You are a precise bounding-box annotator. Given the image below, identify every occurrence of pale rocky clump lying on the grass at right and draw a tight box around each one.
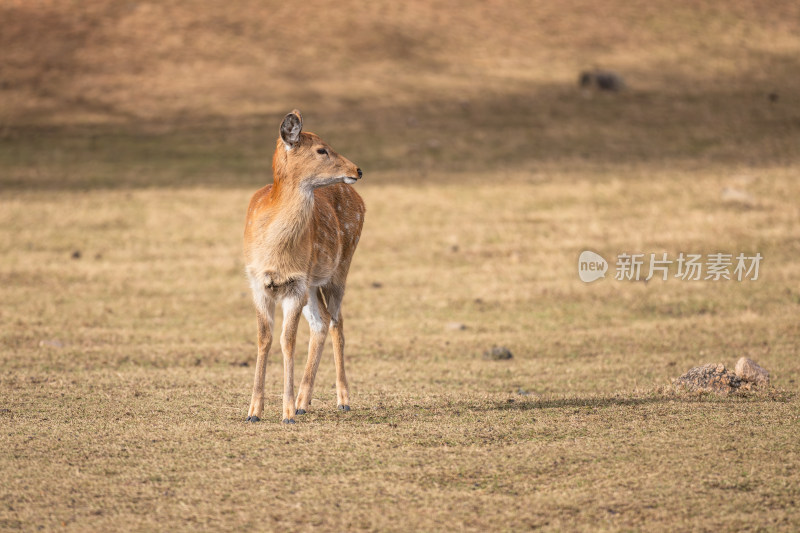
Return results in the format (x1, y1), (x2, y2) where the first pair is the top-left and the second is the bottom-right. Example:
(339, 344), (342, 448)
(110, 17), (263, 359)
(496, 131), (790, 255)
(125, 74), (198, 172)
(673, 357), (769, 395)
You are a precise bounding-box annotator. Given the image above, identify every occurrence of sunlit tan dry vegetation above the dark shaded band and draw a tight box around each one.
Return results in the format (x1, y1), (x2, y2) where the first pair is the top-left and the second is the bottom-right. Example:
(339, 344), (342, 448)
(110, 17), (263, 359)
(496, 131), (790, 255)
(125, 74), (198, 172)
(1, 0), (800, 124)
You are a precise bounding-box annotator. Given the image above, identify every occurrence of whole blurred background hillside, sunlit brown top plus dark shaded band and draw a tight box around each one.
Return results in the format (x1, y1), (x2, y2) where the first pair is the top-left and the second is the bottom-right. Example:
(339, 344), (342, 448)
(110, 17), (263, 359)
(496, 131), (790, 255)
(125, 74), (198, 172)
(0, 0), (800, 187)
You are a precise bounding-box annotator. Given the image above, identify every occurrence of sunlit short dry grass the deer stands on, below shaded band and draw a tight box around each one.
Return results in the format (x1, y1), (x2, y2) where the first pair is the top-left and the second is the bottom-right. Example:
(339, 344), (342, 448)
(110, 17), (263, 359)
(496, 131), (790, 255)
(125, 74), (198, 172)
(0, 172), (800, 530)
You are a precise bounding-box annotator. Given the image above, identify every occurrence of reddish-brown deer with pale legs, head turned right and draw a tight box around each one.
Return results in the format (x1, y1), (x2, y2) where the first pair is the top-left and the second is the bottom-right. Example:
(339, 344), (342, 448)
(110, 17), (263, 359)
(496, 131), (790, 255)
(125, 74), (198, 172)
(244, 109), (365, 424)
